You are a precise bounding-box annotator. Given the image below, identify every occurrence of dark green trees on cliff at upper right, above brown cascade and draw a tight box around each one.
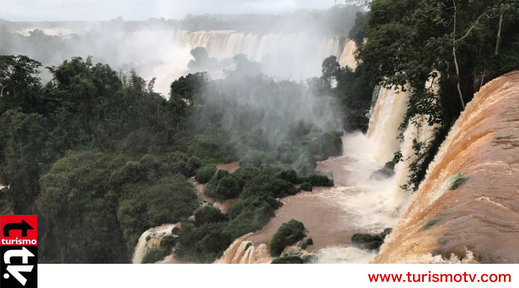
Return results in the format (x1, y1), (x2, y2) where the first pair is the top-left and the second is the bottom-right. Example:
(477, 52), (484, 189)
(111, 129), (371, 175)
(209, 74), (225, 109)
(356, 0), (519, 190)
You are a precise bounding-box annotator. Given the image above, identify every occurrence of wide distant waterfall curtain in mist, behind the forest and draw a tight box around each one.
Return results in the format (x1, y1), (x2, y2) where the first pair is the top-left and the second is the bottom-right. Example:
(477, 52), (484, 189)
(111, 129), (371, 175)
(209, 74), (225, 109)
(174, 31), (350, 80)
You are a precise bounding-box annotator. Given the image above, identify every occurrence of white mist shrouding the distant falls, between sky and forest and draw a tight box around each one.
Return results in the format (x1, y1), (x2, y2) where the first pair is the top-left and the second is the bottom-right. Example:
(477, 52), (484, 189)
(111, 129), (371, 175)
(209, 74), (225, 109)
(0, 5), (360, 98)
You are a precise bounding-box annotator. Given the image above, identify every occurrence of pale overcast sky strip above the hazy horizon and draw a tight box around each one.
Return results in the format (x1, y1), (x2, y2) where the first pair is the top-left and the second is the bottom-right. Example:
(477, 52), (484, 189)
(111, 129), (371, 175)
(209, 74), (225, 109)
(0, 0), (344, 21)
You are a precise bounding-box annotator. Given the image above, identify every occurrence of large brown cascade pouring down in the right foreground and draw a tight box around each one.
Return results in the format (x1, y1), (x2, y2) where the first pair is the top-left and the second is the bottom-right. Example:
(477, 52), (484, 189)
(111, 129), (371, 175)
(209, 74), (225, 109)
(375, 72), (519, 263)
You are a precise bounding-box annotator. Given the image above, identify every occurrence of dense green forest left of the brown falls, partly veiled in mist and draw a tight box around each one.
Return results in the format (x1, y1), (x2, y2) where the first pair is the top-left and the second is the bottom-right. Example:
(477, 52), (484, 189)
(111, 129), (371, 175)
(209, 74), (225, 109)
(0, 56), (348, 263)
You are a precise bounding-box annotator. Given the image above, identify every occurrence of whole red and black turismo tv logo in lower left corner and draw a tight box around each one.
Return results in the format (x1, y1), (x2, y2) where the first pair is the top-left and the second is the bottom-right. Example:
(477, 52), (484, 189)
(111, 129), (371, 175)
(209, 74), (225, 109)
(0, 215), (38, 288)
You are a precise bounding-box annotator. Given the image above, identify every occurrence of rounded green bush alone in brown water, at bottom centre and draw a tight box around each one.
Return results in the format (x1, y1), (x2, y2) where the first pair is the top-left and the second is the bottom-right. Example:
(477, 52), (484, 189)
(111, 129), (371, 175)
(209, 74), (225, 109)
(270, 220), (306, 256)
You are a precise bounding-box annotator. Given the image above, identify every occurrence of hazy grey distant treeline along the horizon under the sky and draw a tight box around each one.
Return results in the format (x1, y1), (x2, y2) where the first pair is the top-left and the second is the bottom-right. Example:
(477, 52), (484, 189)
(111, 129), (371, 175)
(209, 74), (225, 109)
(0, 5), (363, 36)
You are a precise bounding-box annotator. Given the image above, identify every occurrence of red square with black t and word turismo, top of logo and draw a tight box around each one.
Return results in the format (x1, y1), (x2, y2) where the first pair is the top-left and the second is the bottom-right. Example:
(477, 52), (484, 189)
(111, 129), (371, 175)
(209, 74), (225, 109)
(0, 215), (38, 246)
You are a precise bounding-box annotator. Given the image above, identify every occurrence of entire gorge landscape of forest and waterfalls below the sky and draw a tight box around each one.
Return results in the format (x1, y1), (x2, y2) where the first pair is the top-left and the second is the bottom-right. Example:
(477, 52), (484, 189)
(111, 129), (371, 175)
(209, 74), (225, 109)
(0, 0), (519, 264)
